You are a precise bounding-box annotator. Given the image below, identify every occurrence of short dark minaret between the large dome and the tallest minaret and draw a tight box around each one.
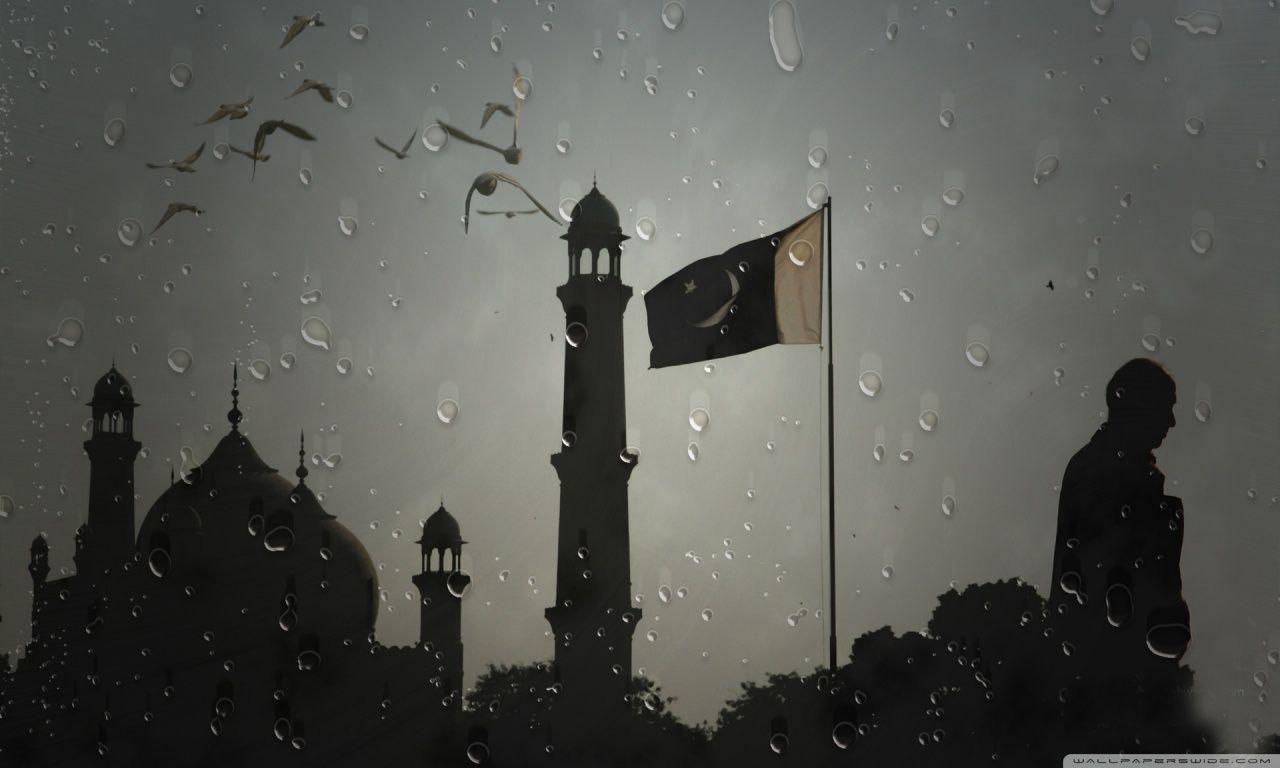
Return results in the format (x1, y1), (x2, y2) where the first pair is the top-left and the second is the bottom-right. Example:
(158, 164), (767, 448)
(413, 499), (471, 707)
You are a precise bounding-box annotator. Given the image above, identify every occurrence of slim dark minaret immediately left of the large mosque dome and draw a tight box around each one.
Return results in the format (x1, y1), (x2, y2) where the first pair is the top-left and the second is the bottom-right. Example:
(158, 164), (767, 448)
(77, 364), (142, 570)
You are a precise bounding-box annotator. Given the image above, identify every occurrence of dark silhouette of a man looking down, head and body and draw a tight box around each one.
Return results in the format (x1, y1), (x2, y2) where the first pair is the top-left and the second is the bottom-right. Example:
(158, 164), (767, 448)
(1050, 358), (1190, 671)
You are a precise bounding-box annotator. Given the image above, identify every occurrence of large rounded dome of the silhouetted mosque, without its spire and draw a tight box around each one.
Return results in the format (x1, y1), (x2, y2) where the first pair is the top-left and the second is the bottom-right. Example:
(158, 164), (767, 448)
(137, 430), (378, 641)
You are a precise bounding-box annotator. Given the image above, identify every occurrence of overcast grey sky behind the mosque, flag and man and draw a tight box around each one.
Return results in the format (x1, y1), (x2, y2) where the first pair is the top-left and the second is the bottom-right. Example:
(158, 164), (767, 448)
(0, 0), (1280, 745)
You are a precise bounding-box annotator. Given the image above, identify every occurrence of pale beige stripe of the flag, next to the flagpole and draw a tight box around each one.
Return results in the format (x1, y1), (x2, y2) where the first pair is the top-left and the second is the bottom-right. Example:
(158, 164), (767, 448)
(773, 210), (826, 344)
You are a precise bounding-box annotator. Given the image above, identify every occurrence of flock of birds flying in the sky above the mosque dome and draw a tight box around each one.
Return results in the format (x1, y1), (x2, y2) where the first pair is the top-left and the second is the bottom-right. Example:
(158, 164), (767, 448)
(146, 12), (559, 234)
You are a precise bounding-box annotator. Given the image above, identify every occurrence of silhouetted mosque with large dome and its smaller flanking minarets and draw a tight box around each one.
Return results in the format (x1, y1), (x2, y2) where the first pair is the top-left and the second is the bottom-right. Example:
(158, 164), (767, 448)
(0, 366), (466, 765)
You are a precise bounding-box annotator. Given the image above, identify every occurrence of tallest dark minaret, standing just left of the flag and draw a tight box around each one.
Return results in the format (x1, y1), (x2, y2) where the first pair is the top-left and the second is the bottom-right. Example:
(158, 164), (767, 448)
(547, 183), (640, 712)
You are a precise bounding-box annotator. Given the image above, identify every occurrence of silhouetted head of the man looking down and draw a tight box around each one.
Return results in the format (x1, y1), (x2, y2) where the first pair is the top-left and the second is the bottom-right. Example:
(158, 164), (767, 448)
(1107, 357), (1178, 451)
